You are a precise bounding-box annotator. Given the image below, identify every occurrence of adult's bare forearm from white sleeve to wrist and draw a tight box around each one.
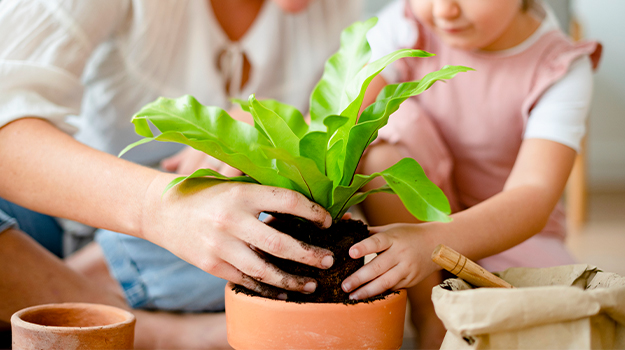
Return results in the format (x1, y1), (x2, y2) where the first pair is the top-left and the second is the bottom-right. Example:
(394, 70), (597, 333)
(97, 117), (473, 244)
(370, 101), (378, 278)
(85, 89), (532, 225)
(0, 118), (168, 236)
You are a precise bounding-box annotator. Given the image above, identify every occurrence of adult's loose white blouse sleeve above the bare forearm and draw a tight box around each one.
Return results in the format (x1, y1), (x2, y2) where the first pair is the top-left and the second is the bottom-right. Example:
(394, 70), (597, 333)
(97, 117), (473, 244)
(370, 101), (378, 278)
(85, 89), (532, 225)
(0, 0), (125, 132)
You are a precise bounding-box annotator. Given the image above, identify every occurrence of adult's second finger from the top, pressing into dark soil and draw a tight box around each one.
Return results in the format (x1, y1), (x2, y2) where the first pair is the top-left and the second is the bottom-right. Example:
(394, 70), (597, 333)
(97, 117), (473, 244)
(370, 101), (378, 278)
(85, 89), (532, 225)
(241, 216), (334, 270)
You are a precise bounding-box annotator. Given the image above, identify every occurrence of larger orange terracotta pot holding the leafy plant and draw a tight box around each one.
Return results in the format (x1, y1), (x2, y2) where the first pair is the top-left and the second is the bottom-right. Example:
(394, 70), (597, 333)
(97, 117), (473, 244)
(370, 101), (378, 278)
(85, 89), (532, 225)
(226, 283), (406, 350)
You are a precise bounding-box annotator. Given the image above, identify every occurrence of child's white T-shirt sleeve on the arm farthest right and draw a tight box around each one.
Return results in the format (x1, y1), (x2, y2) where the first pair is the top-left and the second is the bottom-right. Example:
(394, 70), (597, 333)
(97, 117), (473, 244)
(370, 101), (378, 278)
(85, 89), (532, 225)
(523, 56), (593, 152)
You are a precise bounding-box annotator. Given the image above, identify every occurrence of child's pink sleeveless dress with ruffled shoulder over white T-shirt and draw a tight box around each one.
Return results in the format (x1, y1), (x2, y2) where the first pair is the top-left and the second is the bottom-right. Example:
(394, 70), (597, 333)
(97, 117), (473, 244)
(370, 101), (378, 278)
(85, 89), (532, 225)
(380, 1), (600, 271)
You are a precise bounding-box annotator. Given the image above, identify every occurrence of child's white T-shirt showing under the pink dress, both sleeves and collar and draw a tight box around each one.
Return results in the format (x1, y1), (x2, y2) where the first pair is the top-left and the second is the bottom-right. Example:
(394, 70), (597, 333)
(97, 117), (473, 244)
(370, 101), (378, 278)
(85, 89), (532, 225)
(367, 0), (593, 151)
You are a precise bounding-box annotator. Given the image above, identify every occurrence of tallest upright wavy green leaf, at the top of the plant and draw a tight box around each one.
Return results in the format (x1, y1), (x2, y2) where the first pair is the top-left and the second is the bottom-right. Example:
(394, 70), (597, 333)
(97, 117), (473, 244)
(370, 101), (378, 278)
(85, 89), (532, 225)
(310, 17), (378, 131)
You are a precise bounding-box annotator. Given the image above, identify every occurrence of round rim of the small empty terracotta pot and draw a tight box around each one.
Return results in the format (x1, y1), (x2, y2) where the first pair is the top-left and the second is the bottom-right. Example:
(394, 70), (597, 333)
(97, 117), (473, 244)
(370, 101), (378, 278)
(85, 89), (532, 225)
(11, 303), (136, 333)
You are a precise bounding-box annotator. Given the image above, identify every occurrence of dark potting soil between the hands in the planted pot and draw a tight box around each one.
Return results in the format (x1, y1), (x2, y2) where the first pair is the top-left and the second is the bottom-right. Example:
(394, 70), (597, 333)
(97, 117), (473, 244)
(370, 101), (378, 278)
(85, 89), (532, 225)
(235, 214), (389, 303)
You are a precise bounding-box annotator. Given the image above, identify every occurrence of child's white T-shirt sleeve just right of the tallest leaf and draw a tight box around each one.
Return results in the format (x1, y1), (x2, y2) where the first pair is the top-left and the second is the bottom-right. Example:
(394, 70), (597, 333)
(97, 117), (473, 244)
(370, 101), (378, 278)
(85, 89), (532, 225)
(367, 0), (418, 84)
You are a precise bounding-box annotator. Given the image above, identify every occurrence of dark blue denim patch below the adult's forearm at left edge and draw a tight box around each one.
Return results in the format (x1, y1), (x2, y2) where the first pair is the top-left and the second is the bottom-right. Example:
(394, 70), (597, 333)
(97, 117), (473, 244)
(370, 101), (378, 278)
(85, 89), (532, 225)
(0, 198), (63, 258)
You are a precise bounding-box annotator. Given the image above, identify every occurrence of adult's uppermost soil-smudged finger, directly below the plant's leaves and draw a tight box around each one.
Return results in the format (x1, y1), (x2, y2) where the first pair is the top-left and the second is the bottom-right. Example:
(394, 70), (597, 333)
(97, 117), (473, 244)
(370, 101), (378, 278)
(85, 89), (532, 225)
(248, 186), (332, 228)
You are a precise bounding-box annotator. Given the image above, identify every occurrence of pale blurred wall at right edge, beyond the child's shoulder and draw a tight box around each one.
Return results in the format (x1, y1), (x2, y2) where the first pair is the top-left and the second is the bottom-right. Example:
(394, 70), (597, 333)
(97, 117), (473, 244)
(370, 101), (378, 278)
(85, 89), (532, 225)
(572, 0), (625, 192)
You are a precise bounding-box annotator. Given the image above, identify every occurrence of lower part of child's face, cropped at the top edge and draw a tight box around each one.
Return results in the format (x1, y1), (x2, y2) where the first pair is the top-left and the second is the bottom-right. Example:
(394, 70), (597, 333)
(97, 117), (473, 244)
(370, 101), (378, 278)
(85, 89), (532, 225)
(411, 0), (523, 50)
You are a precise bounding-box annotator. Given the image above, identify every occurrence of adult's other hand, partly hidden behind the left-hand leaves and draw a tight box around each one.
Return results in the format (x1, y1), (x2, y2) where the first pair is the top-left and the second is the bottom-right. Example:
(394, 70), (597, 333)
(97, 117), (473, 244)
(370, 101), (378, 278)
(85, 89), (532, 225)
(161, 147), (242, 177)
